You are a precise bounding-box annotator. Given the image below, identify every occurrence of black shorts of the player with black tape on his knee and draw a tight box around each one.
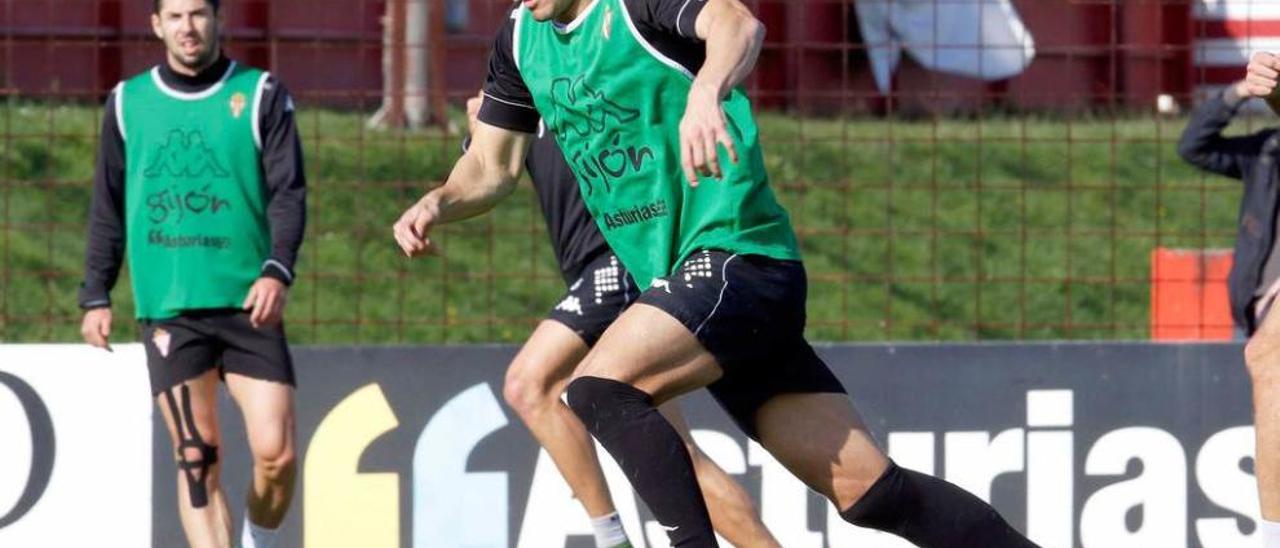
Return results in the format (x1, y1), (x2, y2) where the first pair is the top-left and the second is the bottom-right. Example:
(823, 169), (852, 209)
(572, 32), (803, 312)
(142, 309), (296, 396)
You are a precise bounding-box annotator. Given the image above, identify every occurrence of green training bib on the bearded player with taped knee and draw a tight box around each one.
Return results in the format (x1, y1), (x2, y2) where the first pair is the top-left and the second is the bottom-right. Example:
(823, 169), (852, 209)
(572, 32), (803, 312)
(115, 63), (271, 319)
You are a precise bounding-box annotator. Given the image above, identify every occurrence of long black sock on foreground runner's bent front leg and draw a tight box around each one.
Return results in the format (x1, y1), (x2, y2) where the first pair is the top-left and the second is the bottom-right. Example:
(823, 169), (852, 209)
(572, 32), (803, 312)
(567, 376), (717, 548)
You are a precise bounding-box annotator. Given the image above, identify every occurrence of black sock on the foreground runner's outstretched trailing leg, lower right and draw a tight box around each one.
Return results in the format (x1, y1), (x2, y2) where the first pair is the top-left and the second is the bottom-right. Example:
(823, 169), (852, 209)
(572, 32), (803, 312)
(840, 462), (1036, 548)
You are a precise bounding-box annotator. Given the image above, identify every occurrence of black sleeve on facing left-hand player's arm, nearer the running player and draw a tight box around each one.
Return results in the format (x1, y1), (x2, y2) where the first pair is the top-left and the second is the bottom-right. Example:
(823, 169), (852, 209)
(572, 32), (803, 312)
(259, 77), (307, 284)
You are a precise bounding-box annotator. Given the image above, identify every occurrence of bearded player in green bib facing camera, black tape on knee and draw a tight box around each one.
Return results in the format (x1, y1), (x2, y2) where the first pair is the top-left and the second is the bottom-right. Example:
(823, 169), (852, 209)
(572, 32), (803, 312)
(79, 0), (306, 548)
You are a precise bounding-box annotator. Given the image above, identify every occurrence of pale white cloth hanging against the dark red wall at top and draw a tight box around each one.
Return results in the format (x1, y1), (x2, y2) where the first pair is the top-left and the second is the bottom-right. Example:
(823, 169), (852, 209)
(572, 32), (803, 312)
(855, 0), (1036, 92)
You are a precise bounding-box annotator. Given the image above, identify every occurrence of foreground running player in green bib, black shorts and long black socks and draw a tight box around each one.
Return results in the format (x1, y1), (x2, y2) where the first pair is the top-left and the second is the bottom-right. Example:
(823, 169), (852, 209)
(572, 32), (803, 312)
(394, 0), (1034, 548)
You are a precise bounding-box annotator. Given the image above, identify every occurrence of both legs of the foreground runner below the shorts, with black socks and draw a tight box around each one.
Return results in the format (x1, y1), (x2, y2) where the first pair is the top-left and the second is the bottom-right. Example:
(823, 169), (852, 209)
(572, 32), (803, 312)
(568, 303), (1034, 548)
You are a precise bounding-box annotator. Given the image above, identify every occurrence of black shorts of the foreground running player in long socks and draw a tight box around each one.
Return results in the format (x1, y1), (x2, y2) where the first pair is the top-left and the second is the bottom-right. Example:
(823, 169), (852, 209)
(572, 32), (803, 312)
(639, 251), (846, 439)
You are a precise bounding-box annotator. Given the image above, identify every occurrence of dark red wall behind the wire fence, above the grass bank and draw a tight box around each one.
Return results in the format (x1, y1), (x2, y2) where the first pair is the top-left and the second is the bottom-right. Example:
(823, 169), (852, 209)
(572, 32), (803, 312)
(0, 0), (1194, 111)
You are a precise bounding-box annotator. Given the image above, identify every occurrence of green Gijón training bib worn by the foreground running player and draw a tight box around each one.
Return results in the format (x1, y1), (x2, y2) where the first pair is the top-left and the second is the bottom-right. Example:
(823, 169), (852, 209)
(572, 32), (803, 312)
(512, 0), (800, 288)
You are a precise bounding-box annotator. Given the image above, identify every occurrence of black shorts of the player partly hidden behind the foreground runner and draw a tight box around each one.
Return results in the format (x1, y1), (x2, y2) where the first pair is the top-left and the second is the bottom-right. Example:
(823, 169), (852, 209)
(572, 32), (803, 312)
(547, 254), (640, 346)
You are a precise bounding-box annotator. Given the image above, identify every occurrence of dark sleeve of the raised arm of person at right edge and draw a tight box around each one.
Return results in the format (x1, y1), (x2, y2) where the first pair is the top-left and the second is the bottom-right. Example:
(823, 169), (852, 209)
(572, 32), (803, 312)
(1178, 89), (1271, 179)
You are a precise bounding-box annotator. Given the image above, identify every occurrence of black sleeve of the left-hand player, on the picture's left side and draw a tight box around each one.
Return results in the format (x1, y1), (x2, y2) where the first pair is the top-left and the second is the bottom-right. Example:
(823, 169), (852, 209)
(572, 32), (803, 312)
(78, 91), (124, 310)
